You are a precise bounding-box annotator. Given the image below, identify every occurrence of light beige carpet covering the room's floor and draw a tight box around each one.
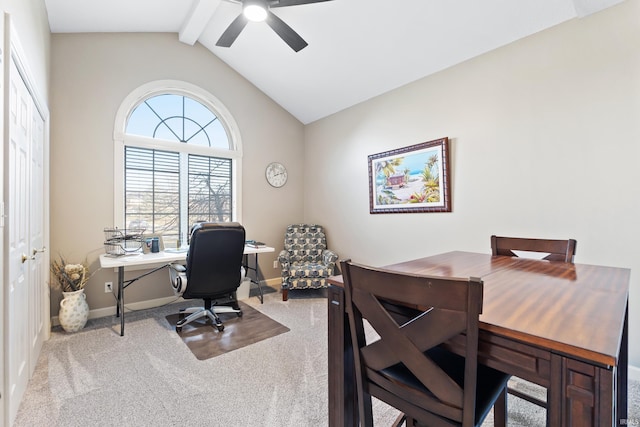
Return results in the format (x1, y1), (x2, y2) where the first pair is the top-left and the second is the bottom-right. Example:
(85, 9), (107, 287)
(13, 287), (640, 427)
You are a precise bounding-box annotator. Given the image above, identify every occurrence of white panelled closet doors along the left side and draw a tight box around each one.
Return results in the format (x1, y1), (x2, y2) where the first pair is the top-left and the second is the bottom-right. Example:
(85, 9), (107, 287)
(4, 56), (48, 423)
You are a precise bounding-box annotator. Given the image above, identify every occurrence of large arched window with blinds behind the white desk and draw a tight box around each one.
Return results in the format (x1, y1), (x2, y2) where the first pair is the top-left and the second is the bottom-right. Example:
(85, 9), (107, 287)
(114, 81), (242, 247)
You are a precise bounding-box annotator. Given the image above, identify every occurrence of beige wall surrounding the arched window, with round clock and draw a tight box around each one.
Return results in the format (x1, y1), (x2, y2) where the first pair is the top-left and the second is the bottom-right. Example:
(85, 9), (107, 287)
(51, 34), (304, 316)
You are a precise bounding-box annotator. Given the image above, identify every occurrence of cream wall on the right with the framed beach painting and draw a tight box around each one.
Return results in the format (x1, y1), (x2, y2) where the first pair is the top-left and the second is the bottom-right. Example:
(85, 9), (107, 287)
(304, 0), (640, 367)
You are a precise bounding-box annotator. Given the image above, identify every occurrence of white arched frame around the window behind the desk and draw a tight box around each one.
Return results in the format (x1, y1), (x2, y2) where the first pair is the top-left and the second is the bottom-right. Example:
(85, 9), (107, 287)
(113, 80), (242, 234)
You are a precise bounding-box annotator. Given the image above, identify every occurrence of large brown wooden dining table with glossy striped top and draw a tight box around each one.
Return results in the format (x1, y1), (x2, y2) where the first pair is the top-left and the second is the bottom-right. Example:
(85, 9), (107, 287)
(328, 251), (630, 427)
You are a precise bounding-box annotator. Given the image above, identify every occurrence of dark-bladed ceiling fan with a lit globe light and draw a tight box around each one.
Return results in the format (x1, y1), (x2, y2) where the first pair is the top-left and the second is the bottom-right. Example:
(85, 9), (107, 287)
(216, 0), (331, 52)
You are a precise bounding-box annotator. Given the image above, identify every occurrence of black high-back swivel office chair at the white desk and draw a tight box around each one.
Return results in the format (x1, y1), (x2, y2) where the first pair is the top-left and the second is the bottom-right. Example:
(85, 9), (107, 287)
(169, 222), (245, 332)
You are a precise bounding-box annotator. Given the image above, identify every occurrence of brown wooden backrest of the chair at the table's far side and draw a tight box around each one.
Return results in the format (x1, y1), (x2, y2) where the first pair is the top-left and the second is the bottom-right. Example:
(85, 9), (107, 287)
(491, 236), (577, 263)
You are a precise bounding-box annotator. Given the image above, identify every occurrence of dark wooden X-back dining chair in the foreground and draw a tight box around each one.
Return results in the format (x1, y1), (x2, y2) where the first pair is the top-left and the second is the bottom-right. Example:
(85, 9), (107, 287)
(342, 261), (509, 427)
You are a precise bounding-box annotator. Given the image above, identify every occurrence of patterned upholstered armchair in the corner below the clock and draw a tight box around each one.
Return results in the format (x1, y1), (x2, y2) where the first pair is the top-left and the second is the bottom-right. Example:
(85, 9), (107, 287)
(278, 224), (338, 301)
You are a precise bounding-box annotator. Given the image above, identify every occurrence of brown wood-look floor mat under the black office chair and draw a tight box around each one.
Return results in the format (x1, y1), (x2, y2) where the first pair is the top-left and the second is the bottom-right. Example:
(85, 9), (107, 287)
(166, 301), (289, 360)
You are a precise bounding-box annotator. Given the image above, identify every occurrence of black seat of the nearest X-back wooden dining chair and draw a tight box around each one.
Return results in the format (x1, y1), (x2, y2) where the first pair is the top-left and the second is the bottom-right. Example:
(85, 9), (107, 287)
(381, 348), (510, 426)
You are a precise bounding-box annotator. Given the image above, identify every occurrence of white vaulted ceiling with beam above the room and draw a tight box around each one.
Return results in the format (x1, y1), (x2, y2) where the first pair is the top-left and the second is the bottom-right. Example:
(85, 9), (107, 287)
(45, 0), (623, 124)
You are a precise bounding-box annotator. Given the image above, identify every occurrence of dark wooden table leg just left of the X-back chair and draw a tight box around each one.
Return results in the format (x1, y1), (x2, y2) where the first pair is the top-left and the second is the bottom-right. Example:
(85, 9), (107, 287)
(327, 285), (358, 427)
